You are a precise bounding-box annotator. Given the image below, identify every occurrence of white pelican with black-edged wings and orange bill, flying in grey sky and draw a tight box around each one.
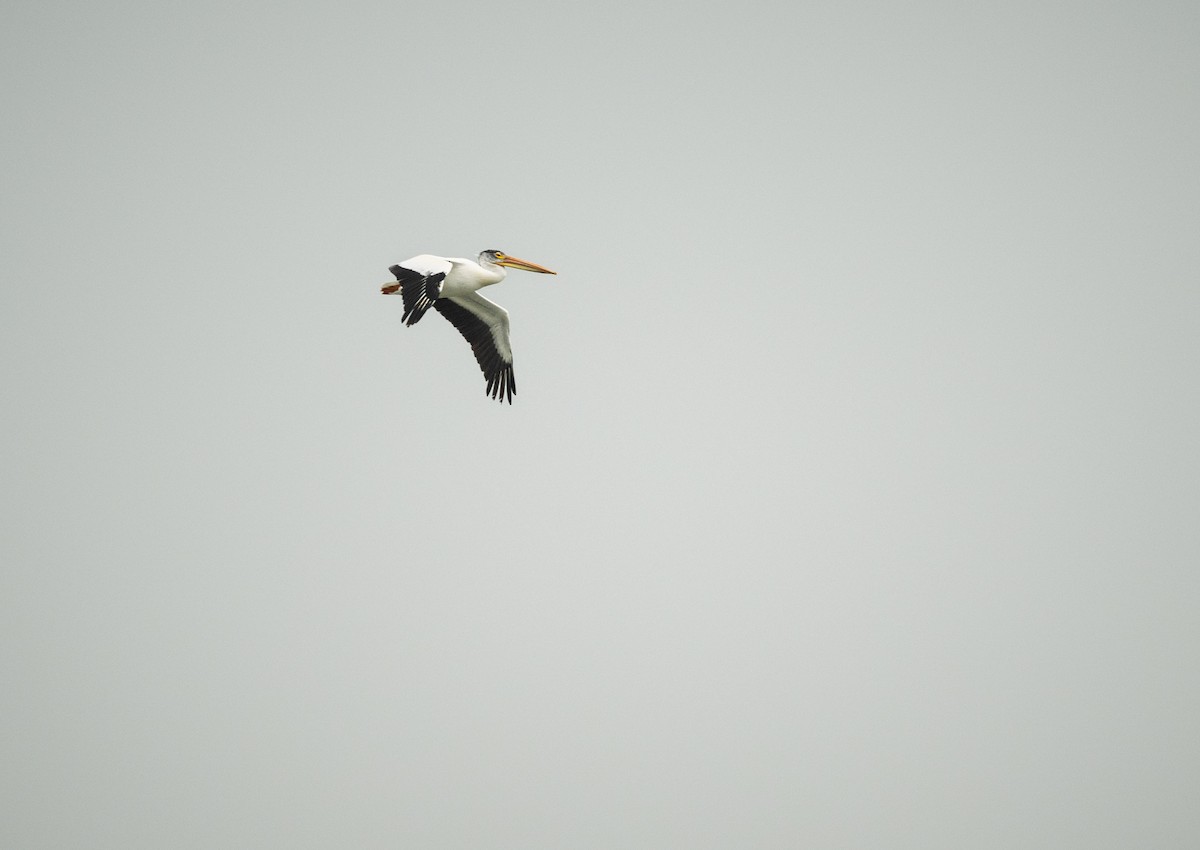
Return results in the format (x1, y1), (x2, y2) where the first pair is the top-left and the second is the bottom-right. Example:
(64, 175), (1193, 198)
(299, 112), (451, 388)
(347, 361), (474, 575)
(382, 251), (558, 405)
